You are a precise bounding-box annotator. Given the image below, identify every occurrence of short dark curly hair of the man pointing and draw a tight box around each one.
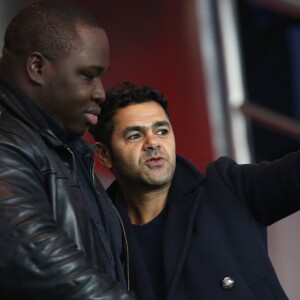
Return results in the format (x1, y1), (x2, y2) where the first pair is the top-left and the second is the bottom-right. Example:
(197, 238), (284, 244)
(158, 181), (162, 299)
(89, 82), (170, 147)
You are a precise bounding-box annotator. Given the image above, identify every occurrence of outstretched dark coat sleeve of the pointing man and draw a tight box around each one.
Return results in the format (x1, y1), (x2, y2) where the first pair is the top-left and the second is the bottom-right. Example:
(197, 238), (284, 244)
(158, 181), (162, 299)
(209, 152), (300, 225)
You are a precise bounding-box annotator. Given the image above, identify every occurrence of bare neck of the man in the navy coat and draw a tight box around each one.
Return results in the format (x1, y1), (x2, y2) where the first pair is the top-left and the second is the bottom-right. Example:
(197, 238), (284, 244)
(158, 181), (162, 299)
(122, 186), (170, 225)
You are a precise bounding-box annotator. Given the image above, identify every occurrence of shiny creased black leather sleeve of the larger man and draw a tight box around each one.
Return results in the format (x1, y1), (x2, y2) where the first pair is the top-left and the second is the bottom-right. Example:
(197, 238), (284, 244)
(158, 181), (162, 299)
(0, 134), (135, 300)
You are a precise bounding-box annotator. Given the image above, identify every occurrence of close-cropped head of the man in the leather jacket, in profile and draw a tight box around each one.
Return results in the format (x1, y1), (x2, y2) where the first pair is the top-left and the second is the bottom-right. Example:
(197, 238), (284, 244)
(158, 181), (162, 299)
(0, 0), (109, 135)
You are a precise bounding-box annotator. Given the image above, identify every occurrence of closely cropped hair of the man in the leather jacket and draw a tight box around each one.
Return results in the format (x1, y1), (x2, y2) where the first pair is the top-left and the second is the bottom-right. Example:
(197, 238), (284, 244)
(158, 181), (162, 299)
(4, 0), (102, 60)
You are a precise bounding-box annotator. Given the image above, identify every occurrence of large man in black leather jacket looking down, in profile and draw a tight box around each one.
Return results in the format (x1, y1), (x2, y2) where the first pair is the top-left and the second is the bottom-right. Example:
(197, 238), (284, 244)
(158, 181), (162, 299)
(0, 1), (134, 300)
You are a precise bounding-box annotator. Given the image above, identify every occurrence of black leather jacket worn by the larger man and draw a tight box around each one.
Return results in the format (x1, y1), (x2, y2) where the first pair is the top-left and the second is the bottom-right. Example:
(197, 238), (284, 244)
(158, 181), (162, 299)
(0, 85), (134, 300)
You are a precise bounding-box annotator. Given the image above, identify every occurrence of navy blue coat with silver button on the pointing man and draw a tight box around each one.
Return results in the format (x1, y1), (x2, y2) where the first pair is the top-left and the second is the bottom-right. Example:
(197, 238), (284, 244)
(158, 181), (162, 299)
(109, 153), (300, 300)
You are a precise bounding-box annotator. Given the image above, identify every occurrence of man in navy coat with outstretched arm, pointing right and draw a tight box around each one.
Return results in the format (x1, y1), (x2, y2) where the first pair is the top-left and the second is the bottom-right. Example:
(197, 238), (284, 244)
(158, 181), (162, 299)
(90, 83), (300, 300)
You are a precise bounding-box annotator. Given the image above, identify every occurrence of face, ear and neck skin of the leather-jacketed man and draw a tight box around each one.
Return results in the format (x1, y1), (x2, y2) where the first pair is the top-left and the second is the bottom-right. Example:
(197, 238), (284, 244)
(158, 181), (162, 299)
(0, 25), (109, 135)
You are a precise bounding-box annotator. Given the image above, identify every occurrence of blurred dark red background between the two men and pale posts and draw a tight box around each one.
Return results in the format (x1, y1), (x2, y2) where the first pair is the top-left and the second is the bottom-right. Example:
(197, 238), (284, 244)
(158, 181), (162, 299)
(72, 0), (213, 170)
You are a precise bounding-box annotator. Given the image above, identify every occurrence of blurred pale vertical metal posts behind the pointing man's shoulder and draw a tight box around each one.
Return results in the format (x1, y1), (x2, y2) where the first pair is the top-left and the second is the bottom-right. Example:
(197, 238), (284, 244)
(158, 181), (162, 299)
(197, 0), (251, 163)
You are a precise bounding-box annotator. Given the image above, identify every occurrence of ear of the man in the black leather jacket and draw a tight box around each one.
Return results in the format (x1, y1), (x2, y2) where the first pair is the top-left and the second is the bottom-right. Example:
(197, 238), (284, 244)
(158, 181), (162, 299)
(26, 52), (46, 84)
